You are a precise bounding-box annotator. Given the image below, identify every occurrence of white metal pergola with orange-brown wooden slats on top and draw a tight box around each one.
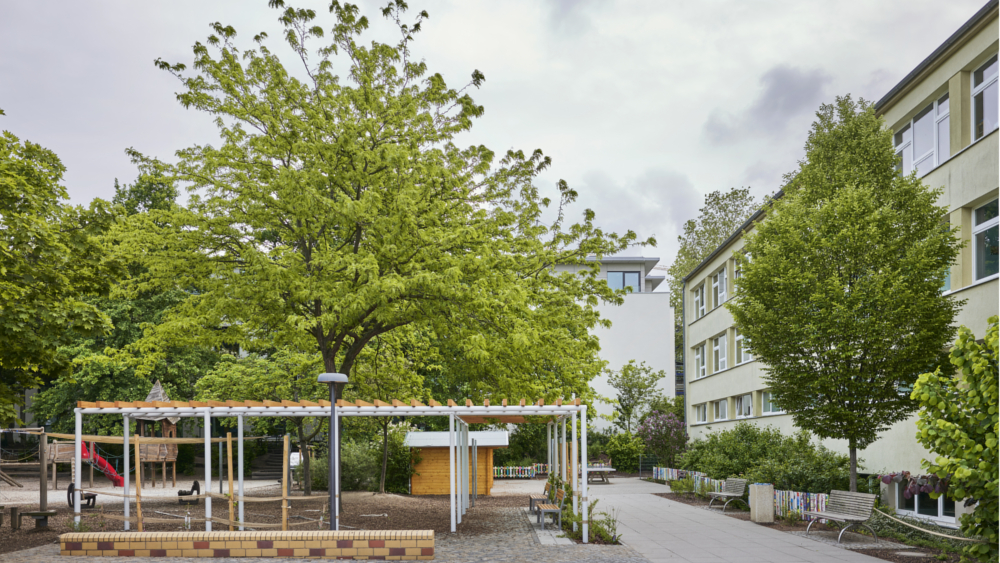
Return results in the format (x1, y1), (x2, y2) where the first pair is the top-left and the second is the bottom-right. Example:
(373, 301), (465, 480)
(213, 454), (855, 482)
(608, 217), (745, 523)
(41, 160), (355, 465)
(73, 399), (589, 543)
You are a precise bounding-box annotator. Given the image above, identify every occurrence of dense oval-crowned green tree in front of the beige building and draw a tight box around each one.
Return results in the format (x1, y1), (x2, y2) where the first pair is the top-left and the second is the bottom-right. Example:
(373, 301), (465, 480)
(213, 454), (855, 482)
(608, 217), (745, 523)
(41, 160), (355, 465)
(727, 96), (959, 491)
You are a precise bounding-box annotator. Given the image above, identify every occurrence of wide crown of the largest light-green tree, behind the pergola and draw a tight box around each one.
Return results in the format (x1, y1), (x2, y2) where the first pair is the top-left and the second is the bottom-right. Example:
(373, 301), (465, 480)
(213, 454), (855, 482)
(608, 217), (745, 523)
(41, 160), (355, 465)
(113, 1), (636, 404)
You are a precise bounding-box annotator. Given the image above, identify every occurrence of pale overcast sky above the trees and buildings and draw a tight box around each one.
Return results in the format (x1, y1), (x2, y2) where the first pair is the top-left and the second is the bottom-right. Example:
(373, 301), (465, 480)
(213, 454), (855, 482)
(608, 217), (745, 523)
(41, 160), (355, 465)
(0, 0), (985, 280)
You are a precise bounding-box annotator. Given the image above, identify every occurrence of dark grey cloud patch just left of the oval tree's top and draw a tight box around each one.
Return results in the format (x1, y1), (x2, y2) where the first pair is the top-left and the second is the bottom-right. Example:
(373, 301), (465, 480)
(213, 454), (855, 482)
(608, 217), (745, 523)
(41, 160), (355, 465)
(704, 64), (832, 144)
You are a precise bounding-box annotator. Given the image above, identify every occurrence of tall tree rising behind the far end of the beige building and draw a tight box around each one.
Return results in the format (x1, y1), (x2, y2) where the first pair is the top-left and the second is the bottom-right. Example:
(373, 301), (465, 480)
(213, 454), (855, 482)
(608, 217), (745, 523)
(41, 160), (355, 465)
(667, 188), (760, 358)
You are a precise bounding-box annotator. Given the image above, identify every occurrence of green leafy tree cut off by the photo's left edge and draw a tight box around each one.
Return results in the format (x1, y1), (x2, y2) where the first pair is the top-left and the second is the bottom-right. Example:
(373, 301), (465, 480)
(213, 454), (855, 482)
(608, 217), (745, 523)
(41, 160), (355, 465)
(0, 131), (119, 425)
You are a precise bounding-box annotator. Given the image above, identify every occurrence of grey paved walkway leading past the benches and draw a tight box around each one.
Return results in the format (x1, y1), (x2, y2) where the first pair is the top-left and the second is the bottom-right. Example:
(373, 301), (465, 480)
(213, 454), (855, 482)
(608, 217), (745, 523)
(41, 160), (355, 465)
(588, 478), (881, 563)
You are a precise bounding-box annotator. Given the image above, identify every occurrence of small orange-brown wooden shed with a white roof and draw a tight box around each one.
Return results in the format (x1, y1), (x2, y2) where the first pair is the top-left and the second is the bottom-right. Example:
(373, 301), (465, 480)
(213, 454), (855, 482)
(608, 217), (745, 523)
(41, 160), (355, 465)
(404, 430), (509, 495)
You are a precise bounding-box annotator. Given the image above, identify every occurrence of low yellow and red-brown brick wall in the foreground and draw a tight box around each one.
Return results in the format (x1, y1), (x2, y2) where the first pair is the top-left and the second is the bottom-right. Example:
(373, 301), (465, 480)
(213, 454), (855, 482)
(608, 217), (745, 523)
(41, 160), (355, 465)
(59, 530), (434, 560)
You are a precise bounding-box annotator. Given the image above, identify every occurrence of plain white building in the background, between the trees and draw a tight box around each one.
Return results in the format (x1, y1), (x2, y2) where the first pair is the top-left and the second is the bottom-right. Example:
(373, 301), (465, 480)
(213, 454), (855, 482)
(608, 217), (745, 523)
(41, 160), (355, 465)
(556, 256), (676, 429)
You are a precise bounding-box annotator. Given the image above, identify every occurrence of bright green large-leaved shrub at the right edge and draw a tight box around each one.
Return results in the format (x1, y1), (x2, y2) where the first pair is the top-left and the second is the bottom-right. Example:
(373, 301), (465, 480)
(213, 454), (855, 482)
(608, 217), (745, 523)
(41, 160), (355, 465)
(910, 316), (1000, 561)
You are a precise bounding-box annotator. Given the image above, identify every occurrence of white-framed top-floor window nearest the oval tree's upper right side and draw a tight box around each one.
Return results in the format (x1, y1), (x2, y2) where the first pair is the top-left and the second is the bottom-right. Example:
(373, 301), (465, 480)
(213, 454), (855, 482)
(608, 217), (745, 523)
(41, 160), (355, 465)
(894, 94), (951, 176)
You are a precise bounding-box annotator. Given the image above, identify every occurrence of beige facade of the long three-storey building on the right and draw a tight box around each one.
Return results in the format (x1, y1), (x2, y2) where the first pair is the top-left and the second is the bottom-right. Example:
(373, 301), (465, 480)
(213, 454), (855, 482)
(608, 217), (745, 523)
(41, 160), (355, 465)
(684, 2), (1000, 525)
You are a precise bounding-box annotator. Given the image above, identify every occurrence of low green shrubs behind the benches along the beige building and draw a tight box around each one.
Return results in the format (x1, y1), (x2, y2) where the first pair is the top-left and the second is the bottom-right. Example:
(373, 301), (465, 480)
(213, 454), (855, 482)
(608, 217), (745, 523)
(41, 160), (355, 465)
(680, 422), (850, 493)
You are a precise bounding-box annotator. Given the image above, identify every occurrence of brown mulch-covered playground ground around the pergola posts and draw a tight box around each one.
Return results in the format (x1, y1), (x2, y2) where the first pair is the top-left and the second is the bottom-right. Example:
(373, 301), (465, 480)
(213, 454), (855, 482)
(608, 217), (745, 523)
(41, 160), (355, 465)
(0, 485), (528, 554)
